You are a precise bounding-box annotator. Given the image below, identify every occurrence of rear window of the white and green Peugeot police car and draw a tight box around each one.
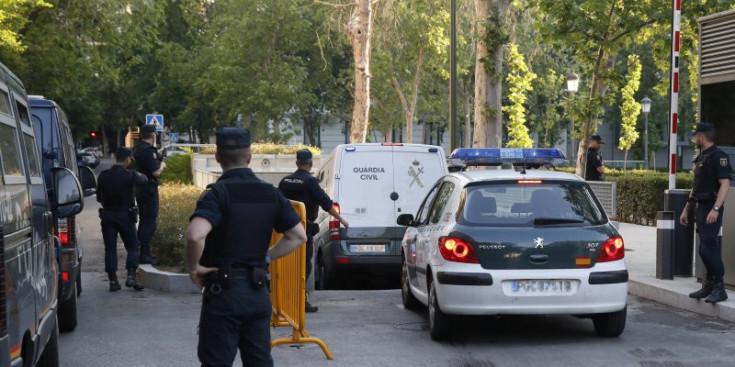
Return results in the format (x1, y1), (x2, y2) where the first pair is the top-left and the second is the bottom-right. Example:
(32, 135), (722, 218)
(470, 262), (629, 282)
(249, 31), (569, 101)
(460, 180), (607, 227)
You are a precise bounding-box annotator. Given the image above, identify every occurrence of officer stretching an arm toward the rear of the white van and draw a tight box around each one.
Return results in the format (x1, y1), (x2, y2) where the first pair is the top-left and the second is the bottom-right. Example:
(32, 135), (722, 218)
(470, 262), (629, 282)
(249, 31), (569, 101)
(278, 149), (349, 312)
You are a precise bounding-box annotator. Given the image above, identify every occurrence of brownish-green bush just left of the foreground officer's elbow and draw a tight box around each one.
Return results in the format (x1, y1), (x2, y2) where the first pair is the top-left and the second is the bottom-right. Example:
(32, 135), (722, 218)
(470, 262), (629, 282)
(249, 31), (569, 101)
(151, 183), (202, 272)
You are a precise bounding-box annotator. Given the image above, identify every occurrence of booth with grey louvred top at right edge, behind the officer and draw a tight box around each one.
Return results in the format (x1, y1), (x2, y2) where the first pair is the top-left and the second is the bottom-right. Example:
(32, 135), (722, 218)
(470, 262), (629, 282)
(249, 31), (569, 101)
(696, 10), (735, 287)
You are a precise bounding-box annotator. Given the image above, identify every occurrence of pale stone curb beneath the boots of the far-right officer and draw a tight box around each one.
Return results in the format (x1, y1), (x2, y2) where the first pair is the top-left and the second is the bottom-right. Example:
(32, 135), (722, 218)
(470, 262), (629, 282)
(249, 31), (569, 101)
(628, 279), (735, 323)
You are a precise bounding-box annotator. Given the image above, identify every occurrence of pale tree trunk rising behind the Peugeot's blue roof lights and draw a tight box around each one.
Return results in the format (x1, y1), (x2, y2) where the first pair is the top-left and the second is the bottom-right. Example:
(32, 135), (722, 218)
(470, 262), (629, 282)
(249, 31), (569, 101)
(472, 0), (490, 148)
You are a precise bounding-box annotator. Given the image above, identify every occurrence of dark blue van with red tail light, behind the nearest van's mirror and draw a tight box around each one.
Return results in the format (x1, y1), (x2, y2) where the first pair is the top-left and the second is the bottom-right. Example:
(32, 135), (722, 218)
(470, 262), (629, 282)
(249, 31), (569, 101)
(28, 96), (97, 332)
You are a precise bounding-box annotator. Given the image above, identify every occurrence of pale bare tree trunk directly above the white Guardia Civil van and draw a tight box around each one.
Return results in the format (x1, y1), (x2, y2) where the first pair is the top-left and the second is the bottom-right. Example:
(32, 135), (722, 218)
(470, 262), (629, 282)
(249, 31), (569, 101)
(345, 0), (374, 144)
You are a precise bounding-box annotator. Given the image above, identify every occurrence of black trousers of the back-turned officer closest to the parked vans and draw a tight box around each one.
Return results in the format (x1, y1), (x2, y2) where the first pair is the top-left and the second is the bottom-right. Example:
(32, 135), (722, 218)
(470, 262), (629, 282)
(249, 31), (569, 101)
(100, 210), (139, 273)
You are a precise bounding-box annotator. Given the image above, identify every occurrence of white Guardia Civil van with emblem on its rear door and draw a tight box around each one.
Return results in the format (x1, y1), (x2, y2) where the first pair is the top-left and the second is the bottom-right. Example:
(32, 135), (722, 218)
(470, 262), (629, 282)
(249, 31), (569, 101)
(314, 143), (447, 289)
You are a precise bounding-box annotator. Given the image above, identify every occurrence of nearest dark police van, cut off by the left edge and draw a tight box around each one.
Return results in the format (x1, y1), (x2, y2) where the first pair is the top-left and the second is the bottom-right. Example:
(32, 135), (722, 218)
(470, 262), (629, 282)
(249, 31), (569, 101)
(0, 59), (83, 367)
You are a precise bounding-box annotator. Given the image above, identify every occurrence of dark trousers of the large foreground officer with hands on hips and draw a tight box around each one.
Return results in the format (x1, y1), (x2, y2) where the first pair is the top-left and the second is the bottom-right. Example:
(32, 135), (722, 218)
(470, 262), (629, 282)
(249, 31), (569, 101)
(198, 276), (273, 367)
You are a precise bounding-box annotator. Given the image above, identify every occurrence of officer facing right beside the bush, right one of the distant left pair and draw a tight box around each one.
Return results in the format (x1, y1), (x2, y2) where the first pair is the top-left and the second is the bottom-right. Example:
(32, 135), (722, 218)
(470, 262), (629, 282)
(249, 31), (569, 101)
(133, 125), (166, 265)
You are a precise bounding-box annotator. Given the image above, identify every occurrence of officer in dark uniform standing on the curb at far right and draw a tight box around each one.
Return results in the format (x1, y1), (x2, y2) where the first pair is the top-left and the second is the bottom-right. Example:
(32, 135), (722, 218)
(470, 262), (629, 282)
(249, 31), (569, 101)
(679, 123), (732, 303)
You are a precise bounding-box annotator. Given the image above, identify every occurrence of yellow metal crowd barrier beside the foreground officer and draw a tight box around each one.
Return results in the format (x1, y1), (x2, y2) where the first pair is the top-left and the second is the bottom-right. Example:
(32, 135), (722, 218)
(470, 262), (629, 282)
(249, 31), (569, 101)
(269, 201), (332, 359)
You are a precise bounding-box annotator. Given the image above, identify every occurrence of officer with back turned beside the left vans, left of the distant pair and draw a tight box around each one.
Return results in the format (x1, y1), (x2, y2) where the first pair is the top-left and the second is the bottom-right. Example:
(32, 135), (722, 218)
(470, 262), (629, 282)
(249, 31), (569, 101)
(97, 147), (148, 292)
